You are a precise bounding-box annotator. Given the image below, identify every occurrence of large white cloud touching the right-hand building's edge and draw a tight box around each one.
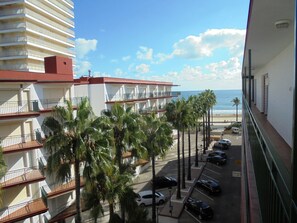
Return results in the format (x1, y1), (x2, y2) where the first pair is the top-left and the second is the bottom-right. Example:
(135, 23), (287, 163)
(172, 29), (245, 58)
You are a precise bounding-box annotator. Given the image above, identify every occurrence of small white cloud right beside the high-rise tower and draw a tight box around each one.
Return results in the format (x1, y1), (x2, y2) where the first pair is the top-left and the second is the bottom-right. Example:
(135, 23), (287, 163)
(74, 38), (97, 59)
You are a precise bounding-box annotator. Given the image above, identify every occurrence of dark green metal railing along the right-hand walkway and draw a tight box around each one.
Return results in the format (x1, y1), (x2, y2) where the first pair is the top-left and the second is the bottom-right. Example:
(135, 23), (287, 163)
(243, 100), (291, 222)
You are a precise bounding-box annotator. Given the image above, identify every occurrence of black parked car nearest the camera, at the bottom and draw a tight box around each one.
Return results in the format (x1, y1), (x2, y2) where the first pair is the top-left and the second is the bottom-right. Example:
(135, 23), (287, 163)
(185, 197), (213, 220)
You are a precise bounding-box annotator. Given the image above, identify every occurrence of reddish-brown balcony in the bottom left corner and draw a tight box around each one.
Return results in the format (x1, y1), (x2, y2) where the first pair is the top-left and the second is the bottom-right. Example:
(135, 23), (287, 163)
(0, 198), (48, 223)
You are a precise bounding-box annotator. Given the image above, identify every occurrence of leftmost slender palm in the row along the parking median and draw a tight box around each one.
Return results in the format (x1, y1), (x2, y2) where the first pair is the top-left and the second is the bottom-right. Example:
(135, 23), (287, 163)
(165, 99), (184, 199)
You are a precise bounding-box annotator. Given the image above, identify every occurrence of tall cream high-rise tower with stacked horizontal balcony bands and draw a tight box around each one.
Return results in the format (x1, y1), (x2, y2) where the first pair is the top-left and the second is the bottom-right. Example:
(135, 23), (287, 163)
(0, 0), (74, 73)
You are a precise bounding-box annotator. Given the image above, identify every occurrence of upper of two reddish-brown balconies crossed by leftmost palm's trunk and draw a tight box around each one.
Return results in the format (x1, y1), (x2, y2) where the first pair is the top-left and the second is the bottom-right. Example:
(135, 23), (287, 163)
(41, 177), (85, 203)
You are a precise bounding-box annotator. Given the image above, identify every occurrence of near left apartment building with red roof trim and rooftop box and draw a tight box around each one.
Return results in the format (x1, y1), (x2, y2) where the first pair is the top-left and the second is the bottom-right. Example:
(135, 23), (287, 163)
(0, 57), (83, 223)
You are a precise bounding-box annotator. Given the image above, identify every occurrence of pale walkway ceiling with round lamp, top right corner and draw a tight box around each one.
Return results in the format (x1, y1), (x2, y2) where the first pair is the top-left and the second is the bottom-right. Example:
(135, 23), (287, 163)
(243, 0), (295, 72)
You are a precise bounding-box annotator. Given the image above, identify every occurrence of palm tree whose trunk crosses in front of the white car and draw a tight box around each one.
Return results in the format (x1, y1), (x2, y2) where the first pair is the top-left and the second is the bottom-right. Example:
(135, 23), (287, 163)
(143, 113), (173, 223)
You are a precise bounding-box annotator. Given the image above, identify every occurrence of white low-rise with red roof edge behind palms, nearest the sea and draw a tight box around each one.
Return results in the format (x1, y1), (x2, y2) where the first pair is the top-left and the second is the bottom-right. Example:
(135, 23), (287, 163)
(74, 77), (179, 116)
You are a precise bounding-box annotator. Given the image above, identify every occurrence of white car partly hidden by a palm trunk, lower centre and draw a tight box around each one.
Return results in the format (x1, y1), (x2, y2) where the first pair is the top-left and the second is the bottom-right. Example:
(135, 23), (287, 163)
(136, 190), (165, 207)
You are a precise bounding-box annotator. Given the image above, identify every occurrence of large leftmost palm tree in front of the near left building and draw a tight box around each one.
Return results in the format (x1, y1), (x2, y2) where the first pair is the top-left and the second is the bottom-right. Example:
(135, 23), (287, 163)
(42, 98), (94, 223)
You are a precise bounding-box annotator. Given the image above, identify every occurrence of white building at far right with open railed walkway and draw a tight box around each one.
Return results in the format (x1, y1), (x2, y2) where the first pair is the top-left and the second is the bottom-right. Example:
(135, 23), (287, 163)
(241, 0), (297, 223)
